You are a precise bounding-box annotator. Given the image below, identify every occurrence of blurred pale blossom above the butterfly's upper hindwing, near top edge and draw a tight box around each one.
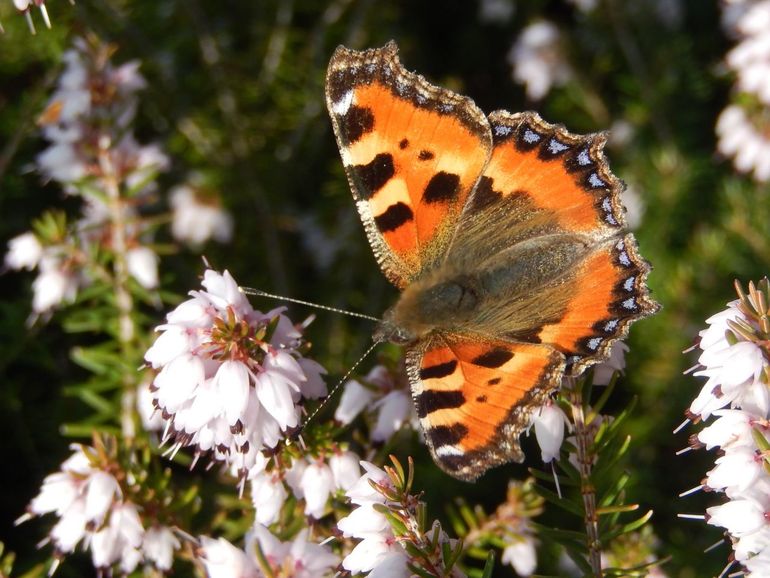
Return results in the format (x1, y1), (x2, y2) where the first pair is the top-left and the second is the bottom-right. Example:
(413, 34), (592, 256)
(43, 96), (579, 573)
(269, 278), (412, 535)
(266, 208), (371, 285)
(508, 21), (572, 100)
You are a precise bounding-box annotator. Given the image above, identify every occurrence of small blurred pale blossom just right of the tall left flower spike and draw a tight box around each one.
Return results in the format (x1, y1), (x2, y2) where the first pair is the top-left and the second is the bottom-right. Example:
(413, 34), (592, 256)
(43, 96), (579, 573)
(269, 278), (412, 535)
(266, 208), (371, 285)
(171, 185), (233, 247)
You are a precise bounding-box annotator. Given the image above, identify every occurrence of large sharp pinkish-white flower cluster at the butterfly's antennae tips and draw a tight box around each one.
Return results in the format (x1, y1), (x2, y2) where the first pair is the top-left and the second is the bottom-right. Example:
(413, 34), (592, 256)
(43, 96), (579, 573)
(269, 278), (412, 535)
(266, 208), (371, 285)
(145, 269), (326, 476)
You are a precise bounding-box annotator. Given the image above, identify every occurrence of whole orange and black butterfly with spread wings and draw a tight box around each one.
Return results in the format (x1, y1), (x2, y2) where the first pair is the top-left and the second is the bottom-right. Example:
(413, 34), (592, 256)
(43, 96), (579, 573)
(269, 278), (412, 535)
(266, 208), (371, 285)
(326, 41), (659, 481)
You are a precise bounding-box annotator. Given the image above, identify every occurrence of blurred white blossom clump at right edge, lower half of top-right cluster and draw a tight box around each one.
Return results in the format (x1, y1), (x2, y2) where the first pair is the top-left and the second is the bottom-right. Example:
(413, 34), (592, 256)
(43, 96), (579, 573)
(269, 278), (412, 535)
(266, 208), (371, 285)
(716, 105), (770, 182)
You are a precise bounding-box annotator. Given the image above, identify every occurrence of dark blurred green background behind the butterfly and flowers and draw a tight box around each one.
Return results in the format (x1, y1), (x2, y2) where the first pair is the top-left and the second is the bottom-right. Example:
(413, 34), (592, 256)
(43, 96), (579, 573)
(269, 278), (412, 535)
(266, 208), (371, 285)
(0, 0), (770, 577)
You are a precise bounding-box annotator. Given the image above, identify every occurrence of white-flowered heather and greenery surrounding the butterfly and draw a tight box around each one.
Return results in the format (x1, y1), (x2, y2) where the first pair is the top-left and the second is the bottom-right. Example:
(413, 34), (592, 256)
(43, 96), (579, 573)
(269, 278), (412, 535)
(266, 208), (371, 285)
(0, 0), (770, 578)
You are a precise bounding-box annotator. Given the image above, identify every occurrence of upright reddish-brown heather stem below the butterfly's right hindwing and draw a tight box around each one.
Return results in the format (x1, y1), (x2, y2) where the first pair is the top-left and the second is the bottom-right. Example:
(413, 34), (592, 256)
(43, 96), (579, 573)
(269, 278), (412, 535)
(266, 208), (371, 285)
(565, 377), (603, 578)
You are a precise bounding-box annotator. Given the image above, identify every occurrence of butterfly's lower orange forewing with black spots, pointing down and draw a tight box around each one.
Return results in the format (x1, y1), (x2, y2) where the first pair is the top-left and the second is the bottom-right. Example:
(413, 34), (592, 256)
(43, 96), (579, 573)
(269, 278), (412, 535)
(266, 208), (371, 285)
(407, 335), (565, 481)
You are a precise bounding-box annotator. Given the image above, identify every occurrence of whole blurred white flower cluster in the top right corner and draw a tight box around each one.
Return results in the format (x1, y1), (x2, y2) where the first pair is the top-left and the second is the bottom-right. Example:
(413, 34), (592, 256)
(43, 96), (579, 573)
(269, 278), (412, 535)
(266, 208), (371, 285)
(716, 0), (770, 182)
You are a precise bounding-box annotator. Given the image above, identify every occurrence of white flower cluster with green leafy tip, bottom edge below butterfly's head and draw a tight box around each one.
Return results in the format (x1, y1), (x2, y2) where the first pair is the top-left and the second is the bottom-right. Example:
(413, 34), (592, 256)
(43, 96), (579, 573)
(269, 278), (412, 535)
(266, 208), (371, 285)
(337, 456), (465, 578)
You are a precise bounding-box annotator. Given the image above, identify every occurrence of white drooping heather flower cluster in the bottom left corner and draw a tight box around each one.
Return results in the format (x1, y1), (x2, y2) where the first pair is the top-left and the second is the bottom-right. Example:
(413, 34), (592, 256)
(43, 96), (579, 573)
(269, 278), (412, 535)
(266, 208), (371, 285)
(17, 444), (180, 574)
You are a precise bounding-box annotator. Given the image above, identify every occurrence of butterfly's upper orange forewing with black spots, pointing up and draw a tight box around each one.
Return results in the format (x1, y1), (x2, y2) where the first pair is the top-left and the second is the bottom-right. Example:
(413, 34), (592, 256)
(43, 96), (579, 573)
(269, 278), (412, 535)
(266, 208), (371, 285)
(326, 42), (492, 288)
